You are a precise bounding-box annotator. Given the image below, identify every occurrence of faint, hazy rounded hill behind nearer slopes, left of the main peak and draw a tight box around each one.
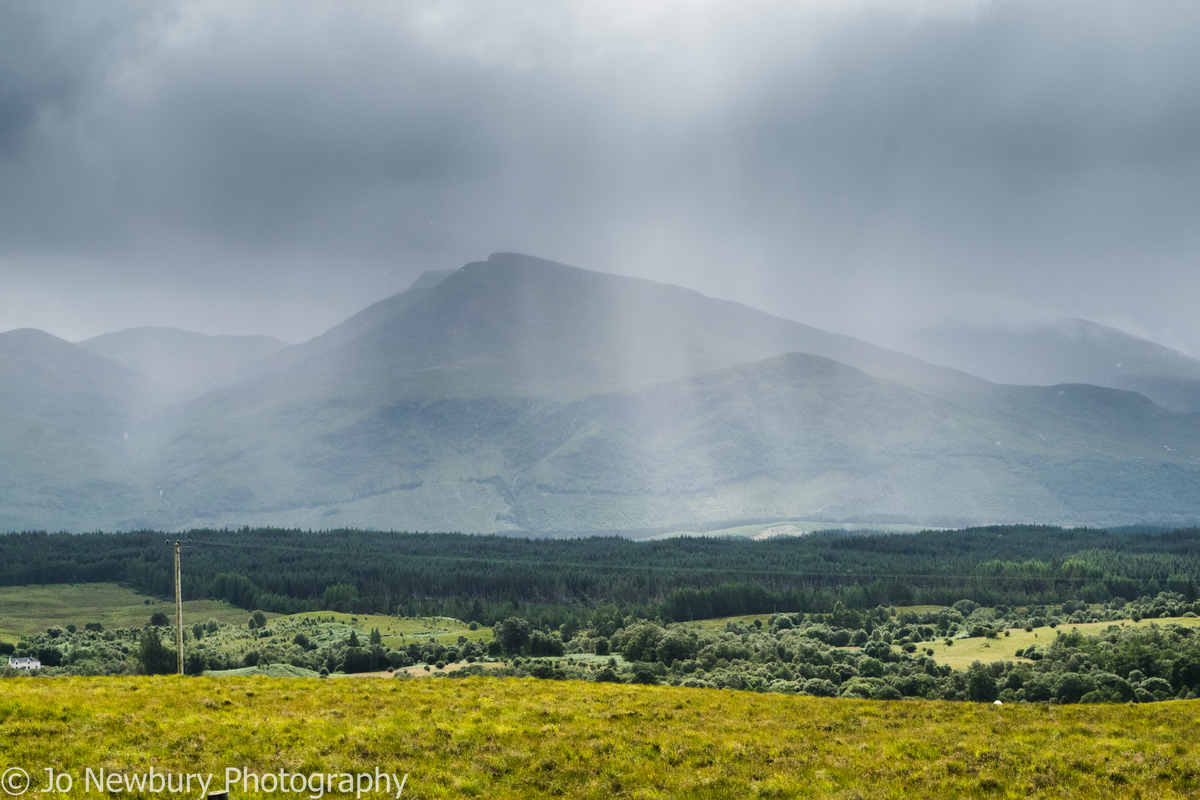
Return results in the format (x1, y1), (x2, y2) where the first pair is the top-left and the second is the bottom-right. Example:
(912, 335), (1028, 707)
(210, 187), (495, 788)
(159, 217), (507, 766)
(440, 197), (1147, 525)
(79, 327), (288, 403)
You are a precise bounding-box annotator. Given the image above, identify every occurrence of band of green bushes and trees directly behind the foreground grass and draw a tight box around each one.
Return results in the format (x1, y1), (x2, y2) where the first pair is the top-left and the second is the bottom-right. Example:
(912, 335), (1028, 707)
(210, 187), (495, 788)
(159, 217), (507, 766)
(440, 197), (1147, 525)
(14, 593), (1200, 703)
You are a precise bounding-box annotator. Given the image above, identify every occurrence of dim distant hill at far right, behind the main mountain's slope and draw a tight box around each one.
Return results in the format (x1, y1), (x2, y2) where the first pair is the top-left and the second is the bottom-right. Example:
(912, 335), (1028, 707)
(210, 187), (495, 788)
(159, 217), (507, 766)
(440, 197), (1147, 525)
(912, 319), (1200, 414)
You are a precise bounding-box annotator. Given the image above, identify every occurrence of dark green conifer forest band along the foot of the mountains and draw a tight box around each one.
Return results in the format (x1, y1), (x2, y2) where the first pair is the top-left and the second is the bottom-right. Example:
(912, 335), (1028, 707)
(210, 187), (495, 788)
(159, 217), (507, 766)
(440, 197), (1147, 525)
(0, 527), (1200, 630)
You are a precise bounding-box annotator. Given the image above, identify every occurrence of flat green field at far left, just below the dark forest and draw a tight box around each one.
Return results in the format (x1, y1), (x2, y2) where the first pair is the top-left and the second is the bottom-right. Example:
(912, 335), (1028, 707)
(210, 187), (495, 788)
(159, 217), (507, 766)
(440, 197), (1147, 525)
(0, 583), (267, 642)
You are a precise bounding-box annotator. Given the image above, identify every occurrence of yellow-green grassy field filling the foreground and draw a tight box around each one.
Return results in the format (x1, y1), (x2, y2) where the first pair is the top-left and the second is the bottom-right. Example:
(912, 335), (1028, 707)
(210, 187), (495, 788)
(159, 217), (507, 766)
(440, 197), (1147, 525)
(0, 678), (1200, 800)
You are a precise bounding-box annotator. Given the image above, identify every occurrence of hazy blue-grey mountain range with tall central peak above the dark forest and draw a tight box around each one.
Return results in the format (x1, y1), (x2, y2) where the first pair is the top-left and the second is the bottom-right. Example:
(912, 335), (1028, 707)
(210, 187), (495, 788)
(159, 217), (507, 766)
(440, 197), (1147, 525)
(0, 253), (1200, 534)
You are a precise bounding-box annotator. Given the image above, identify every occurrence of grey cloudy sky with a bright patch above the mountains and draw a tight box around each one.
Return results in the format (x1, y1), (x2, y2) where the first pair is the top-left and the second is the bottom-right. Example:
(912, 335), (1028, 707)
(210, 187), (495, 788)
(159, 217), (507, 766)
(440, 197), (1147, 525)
(0, 0), (1200, 354)
